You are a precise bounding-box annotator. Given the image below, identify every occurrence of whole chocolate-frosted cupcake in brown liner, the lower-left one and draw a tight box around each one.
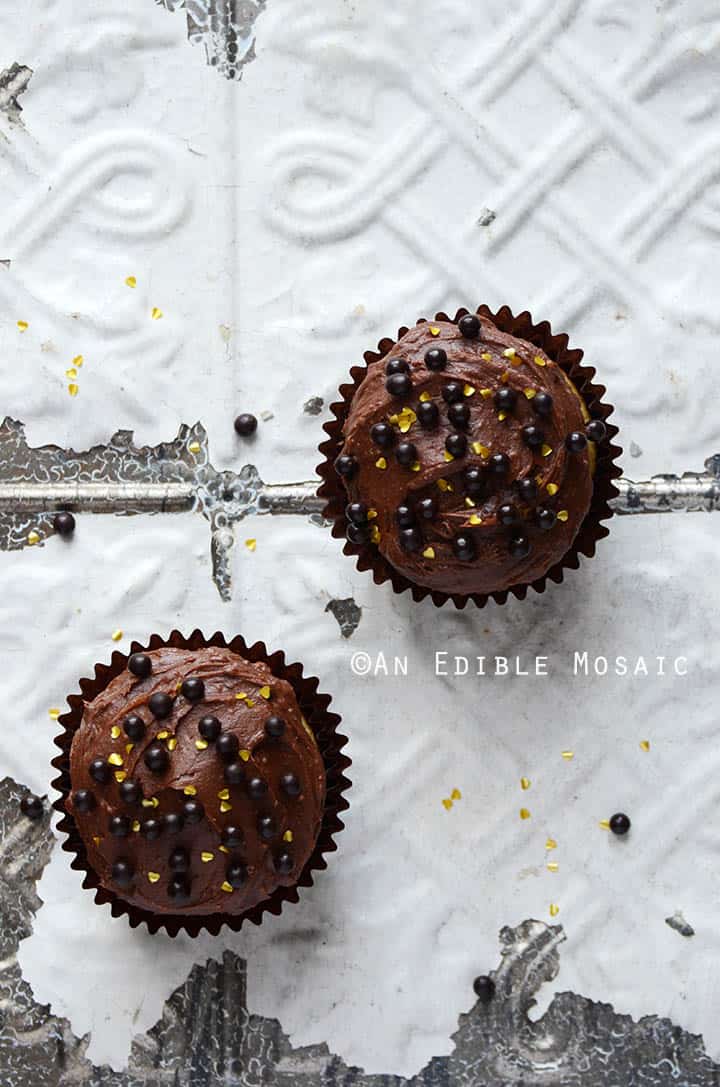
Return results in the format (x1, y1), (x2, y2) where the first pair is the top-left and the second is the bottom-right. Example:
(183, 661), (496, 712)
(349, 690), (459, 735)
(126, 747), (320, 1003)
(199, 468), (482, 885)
(55, 634), (349, 935)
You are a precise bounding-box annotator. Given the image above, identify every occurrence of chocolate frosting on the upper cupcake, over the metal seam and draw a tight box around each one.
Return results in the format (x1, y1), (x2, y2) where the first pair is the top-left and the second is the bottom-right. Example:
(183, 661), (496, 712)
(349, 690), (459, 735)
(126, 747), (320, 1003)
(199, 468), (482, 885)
(342, 316), (595, 595)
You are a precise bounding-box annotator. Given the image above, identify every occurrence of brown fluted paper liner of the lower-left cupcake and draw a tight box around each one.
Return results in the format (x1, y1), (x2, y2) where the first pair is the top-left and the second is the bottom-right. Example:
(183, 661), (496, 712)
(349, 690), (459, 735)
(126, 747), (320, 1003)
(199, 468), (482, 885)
(52, 630), (351, 936)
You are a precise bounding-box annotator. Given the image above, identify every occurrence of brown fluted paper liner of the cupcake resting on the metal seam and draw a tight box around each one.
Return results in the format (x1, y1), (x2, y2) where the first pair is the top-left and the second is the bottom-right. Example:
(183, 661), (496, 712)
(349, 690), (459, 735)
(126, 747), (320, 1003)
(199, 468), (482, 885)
(316, 305), (622, 608)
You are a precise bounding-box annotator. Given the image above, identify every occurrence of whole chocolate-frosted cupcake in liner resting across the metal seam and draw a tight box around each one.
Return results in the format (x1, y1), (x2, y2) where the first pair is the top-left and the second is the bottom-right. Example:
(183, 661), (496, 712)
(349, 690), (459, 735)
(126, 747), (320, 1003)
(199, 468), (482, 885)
(319, 307), (620, 607)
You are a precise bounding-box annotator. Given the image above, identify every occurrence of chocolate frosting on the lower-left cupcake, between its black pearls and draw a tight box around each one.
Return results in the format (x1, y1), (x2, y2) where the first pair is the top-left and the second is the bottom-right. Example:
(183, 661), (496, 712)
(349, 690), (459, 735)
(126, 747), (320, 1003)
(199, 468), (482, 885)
(66, 647), (325, 914)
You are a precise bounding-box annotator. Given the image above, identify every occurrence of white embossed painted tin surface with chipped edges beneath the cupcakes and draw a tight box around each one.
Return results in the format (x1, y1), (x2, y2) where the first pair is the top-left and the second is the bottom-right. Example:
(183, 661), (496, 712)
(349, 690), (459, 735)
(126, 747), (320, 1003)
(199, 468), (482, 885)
(0, 0), (720, 1074)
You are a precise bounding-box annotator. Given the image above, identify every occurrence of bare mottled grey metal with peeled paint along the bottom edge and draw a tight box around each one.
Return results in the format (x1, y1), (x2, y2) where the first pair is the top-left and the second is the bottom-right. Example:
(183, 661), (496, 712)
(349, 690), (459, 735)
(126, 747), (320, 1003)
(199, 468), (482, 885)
(0, 777), (720, 1087)
